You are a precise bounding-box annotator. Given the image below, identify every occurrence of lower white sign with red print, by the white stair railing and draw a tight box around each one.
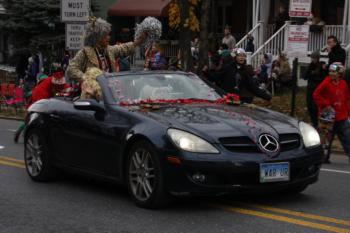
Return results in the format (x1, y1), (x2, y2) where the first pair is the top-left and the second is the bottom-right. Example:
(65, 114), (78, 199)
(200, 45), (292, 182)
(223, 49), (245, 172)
(287, 25), (310, 57)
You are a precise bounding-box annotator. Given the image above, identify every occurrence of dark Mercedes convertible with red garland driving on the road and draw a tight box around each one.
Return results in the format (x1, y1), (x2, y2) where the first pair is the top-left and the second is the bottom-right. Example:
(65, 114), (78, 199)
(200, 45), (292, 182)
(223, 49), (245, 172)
(25, 72), (323, 208)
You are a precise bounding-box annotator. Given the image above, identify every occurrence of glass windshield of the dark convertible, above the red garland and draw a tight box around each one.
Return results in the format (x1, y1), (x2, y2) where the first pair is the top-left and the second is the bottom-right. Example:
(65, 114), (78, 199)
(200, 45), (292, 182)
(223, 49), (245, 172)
(108, 74), (221, 103)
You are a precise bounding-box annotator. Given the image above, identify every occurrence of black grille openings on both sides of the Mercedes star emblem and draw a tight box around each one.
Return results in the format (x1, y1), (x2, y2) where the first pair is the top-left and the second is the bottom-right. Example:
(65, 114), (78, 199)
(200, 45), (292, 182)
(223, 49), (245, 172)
(219, 134), (300, 153)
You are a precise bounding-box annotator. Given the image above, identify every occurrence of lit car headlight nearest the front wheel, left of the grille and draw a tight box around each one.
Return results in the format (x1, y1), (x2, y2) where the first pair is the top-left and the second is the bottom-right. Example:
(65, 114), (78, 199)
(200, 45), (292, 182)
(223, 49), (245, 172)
(168, 129), (220, 154)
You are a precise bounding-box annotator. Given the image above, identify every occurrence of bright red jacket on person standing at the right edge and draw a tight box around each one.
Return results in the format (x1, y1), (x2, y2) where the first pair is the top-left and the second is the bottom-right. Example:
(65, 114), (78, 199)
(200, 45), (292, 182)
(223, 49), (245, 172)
(313, 76), (350, 121)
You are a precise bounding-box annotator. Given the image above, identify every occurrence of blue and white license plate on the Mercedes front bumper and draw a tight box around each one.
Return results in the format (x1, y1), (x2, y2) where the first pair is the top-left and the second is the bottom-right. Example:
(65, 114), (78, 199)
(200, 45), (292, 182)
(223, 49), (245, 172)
(260, 163), (290, 183)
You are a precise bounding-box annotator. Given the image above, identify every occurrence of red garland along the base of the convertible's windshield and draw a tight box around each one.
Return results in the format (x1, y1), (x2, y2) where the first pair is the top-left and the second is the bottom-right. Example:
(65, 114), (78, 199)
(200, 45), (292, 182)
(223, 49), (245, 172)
(119, 94), (240, 109)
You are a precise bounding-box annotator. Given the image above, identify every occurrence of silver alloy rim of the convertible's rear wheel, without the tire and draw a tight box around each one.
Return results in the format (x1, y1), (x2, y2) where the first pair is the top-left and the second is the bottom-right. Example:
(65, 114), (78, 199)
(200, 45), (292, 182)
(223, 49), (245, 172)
(26, 134), (43, 176)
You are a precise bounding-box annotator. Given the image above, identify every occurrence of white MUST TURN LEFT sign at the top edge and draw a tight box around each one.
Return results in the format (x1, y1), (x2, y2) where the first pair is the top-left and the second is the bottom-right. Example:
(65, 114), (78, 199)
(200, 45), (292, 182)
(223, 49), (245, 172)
(61, 0), (90, 22)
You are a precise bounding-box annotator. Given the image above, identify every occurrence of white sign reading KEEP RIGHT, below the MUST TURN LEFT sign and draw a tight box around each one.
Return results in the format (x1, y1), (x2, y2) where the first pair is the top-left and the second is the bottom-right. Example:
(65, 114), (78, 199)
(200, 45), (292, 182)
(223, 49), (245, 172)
(66, 23), (85, 50)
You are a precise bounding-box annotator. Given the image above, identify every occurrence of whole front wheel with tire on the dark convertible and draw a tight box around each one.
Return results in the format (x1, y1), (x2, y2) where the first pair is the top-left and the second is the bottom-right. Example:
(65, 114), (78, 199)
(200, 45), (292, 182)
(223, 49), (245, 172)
(125, 141), (170, 209)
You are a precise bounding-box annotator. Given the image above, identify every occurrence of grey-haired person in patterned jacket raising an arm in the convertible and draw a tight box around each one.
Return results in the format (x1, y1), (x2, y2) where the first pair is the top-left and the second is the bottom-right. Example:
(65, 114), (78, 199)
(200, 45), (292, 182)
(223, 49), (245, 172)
(67, 17), (147, 83)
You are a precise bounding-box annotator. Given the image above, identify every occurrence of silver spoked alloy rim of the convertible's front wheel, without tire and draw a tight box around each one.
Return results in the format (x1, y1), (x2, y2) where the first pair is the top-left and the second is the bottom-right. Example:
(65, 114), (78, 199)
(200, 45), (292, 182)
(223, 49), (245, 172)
(129, 149), (155, 201)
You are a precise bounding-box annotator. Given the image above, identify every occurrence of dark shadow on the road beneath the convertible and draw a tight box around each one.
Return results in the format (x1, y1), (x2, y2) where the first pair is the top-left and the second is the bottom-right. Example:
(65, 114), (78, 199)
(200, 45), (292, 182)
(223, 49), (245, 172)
(41, 173), (312, 213)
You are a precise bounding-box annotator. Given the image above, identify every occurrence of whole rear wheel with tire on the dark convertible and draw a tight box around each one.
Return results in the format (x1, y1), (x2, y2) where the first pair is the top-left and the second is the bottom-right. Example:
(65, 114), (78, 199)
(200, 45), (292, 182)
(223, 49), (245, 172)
(24, 129), (57, 182)
